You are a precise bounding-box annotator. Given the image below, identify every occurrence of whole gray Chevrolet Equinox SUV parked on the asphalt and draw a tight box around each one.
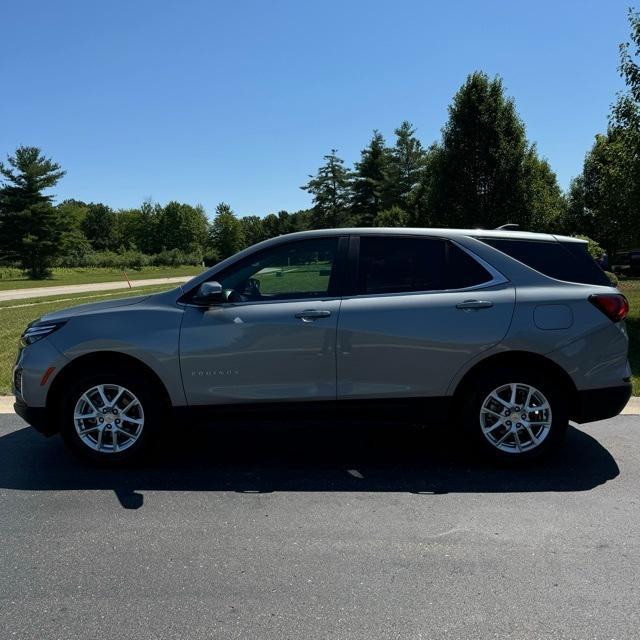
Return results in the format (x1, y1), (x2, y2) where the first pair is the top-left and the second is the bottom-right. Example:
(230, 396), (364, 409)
(13, 229), (631, 463)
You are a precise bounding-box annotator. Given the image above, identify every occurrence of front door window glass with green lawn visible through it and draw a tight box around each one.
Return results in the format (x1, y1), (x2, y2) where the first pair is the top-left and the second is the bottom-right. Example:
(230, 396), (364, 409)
(216, 237), (338, 302)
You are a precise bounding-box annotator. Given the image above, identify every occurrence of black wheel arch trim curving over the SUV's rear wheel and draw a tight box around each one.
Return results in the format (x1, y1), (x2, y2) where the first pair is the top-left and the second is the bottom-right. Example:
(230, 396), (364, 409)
(453, 351), (578, 414)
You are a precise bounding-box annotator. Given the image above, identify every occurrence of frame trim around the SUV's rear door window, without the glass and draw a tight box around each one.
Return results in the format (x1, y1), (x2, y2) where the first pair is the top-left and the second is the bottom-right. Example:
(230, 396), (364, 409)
(345, 233), (509, 298)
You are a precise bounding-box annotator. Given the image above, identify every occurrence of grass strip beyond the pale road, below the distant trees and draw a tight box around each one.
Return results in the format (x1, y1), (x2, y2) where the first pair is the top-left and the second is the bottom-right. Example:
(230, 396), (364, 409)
(0, 266), (202, 291)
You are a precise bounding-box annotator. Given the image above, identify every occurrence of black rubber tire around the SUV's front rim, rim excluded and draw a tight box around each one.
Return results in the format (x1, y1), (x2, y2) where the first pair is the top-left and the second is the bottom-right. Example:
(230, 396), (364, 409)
(56, 367), (166, 466)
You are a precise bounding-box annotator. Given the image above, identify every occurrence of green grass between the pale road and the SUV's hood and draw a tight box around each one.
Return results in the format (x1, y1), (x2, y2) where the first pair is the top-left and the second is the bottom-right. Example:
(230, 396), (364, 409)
(0, 285), (171, 395)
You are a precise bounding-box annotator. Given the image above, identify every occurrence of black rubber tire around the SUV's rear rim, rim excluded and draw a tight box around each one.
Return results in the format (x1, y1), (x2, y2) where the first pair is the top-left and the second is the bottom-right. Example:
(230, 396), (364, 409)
(463, 367), (569, 465)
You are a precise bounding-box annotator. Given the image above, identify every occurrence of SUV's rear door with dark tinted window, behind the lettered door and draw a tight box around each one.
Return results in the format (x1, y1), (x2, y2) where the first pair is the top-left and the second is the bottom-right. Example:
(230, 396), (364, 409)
(337, 235), (515, 399)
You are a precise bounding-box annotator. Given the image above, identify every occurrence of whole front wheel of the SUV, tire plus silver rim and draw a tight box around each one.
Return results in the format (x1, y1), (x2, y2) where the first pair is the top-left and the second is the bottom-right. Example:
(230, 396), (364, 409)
(57, 368), (164, 466)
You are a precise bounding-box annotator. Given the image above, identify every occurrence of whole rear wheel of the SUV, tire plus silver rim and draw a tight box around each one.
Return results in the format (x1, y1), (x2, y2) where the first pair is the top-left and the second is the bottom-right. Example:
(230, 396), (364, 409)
(463, 367), (569, 465)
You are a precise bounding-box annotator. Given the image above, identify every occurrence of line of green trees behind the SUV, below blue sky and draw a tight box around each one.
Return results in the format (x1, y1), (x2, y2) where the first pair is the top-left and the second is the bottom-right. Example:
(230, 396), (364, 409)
(0, 10), (640, 278)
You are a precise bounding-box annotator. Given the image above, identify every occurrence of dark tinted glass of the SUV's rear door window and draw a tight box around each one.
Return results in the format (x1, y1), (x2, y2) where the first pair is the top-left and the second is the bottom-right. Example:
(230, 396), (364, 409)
(357, 236), (491, 294)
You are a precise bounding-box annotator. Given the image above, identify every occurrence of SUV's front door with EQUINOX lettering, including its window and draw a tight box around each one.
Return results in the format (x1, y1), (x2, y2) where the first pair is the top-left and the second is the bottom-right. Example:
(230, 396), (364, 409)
(180, 237), (346, 405)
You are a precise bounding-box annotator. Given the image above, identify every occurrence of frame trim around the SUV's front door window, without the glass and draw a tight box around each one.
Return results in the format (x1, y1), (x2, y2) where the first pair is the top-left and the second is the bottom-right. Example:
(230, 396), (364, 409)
(178, 235), (349, 309)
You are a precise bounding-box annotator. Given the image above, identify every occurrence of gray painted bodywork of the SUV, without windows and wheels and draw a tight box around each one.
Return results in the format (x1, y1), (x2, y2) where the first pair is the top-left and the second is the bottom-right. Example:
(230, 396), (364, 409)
(13, 229), (629, 407)
